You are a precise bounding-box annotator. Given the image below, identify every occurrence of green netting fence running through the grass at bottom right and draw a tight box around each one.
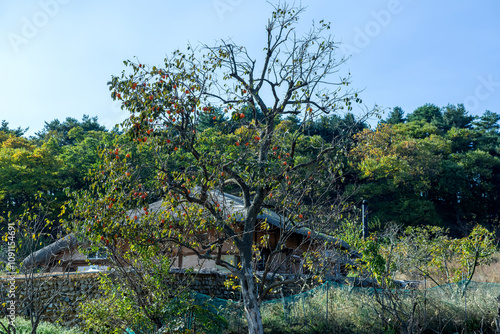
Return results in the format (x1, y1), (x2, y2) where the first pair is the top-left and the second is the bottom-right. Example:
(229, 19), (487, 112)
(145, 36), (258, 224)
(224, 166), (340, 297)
(189, 281), (500, 333)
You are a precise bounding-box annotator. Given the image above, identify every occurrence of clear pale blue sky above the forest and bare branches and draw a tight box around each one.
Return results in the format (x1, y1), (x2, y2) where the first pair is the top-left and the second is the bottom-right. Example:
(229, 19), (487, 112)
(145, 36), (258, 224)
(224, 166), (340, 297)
(0, 0), (500, 135)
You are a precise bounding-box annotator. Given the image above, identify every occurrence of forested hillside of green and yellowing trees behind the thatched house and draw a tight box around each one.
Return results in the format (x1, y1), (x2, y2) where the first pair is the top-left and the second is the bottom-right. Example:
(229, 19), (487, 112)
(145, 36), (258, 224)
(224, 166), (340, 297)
(0, 104), (500, 234)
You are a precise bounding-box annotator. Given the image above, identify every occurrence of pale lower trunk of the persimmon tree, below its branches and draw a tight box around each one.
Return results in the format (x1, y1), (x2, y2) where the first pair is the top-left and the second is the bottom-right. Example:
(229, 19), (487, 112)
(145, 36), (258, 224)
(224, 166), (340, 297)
(240, 268), (264, 334)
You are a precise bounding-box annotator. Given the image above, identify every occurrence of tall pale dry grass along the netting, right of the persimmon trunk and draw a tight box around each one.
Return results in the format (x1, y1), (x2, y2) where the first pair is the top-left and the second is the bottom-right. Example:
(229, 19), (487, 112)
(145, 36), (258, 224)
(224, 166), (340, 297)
(222, 252), (500, 334)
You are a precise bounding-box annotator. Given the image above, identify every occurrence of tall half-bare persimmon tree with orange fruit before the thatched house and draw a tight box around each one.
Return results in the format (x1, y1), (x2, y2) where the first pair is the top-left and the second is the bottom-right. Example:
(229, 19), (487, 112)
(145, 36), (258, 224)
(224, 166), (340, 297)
(70, 4), (361, 333)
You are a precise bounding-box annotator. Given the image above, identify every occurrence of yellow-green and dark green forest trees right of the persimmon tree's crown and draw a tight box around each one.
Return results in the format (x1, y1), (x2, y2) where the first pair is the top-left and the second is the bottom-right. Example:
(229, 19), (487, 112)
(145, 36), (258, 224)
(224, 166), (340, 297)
(352, 104), (500, 235)
